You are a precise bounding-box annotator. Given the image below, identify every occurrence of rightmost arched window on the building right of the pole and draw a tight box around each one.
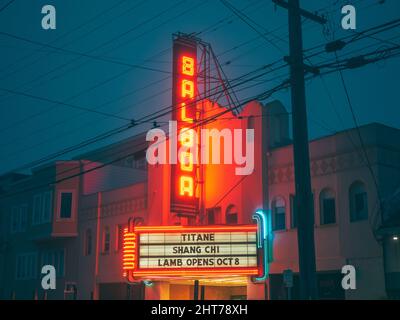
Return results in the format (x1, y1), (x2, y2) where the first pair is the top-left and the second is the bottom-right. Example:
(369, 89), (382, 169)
(349, 181), (368, 222)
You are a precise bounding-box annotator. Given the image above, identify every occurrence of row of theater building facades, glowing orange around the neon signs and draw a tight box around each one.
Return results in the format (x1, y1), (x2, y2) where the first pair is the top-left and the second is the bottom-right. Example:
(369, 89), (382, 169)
(0, 101), (400, 299)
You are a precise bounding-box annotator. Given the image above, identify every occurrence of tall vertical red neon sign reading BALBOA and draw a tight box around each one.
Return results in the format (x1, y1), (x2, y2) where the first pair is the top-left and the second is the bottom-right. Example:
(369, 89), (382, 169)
(171, 37), (199, 214)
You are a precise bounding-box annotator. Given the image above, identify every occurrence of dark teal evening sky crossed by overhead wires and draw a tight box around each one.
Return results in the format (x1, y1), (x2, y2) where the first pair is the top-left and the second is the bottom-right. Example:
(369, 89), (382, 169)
(0, 0), (400, 173)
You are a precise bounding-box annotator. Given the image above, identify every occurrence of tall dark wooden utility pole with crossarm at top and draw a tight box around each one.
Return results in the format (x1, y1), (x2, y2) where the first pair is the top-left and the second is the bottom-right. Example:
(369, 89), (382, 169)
(272, 0), (326, 299)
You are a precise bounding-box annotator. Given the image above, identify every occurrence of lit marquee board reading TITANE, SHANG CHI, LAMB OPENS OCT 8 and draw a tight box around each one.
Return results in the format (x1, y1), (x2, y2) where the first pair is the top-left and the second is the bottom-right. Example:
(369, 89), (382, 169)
(123, 211), (272, 282)
